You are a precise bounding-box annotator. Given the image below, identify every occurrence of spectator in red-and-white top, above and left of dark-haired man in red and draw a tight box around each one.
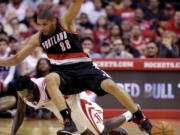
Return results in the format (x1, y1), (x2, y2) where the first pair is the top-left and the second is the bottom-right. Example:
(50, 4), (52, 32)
(130, 25), (146, 54)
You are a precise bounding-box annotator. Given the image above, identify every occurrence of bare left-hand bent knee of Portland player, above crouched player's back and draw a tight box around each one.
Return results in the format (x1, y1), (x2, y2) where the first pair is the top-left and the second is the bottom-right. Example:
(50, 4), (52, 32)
(45, 73), (60, 85)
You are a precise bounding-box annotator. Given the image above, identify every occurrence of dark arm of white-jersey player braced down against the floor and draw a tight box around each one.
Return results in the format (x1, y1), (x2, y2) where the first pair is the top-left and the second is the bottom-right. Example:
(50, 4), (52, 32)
(10, 96), (26, 135)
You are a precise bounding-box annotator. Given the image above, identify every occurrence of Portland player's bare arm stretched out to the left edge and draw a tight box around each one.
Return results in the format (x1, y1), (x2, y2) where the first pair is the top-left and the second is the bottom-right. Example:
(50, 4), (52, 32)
(0, 33), (39, 66)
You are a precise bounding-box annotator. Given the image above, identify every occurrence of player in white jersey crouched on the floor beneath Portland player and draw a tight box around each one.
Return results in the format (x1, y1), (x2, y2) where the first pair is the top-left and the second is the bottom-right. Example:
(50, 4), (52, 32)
(11, 76), (133, 135)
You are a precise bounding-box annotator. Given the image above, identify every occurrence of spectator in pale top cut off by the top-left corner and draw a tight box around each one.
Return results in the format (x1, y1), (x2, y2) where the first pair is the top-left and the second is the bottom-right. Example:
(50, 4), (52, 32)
(0, 0), (9, 25)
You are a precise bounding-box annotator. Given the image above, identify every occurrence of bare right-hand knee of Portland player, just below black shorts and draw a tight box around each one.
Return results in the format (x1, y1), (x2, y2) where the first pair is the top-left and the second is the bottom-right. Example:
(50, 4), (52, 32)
(101, 79), (118, 94)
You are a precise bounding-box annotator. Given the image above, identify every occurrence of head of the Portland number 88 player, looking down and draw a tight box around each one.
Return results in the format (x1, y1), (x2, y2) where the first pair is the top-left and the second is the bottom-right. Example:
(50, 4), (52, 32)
(37, 8), (56, 35)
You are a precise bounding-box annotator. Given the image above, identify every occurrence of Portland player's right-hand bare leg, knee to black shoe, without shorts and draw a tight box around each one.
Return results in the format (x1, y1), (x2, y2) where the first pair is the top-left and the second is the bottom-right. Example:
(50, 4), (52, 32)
(101, 79), (152, 133)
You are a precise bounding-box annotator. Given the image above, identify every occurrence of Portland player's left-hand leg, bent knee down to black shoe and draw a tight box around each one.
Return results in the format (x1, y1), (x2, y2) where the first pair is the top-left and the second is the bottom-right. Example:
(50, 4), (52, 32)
(45, 73), (77, 135)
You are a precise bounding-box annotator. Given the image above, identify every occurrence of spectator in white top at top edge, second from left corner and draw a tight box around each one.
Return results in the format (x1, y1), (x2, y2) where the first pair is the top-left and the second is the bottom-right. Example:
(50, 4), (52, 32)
(8, 0), (28, 21)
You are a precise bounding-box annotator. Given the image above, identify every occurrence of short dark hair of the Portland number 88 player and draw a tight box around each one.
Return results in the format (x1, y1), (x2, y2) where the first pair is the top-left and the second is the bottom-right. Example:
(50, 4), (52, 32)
(37, 8), (55, 20)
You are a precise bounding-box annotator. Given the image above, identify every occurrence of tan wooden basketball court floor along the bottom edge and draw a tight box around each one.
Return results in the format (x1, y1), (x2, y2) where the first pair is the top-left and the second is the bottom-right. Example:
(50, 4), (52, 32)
(0, 119), (180, 135)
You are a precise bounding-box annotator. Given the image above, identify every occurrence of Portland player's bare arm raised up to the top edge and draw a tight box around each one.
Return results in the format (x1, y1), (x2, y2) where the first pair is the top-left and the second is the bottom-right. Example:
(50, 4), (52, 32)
(60, 0), (83, 32)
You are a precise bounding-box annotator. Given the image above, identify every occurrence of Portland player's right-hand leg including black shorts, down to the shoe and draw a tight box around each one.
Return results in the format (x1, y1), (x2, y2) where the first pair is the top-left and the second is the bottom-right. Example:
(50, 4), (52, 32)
(76, 63), (152, 132)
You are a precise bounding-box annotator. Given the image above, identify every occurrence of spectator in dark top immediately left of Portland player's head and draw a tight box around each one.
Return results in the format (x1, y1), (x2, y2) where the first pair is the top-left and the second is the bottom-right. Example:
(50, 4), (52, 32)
(21, 8), (38, 35)
